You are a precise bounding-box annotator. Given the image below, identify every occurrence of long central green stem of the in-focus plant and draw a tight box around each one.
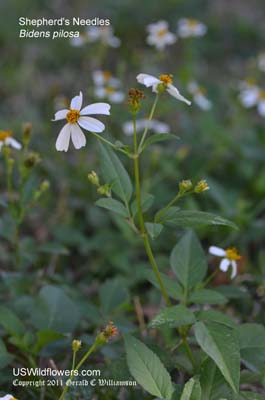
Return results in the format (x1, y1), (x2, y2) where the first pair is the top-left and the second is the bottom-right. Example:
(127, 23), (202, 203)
(133, 115), (170, 305)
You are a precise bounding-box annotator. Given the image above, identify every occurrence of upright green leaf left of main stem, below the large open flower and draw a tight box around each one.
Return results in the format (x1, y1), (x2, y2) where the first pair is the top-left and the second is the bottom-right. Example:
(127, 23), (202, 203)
(99, 143), (133, 203)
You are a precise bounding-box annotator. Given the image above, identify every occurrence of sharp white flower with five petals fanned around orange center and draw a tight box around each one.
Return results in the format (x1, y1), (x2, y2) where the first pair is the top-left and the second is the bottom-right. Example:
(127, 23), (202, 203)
(53, 92), (110, 151)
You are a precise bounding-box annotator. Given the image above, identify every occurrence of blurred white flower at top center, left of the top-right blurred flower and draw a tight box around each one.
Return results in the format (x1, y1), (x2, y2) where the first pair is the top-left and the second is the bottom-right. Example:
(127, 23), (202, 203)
(146, 21), (177, 50)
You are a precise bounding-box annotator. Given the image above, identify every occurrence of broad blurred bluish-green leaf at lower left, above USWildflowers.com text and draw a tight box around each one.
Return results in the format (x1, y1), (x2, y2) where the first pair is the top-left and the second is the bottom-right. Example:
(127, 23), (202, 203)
(31, 285), (80, 333)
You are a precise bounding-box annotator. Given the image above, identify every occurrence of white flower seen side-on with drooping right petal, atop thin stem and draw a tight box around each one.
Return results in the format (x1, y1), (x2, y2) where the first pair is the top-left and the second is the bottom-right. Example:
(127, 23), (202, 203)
(136, 74), (191, 105)
